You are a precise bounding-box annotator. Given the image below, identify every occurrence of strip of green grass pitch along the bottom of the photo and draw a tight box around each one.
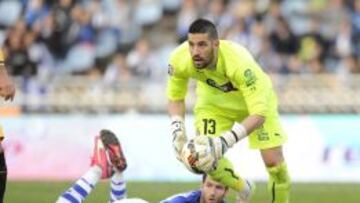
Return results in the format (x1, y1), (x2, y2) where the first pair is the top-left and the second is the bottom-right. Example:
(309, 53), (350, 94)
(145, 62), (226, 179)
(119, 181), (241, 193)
(4, 181), (360, 203)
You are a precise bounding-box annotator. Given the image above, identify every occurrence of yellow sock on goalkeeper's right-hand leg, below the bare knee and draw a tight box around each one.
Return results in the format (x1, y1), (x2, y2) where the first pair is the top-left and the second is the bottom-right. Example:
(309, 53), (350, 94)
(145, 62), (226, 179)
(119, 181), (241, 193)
(267, 162), (291, 203)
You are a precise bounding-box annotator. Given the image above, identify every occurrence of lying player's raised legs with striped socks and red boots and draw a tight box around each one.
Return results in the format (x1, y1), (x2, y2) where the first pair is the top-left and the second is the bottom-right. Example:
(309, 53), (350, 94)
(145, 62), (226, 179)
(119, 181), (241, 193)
(56, 130), (139, 203)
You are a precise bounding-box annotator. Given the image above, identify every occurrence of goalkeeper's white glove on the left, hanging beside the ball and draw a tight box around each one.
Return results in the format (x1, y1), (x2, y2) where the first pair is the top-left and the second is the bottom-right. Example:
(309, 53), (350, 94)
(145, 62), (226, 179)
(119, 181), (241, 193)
(171, 116), (187, 161)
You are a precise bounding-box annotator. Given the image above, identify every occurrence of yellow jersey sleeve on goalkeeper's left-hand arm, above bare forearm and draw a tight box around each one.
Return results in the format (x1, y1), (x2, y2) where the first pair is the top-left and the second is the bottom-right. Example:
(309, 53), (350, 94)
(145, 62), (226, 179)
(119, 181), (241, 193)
(166, 57), (189, 101)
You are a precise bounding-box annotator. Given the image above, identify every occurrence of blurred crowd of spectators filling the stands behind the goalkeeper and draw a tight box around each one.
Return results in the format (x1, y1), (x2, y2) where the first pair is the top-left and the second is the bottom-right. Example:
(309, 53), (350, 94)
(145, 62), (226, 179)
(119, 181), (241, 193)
(0, 0), (360, 84)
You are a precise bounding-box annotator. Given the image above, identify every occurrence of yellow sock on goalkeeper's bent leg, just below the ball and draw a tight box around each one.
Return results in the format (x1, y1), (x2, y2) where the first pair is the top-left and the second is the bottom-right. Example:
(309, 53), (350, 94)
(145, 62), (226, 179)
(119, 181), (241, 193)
(208, 158), (246, 192)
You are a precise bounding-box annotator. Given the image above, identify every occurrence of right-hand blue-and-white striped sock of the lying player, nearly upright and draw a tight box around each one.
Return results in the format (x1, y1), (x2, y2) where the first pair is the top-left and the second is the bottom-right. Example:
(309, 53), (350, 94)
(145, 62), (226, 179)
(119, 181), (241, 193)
(110, 172), (127, 202)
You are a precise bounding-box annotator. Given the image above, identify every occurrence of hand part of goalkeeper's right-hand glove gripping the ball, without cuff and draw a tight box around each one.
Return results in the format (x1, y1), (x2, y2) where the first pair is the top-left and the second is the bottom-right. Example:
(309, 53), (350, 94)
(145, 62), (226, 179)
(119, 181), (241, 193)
(194, 135), (228, 173)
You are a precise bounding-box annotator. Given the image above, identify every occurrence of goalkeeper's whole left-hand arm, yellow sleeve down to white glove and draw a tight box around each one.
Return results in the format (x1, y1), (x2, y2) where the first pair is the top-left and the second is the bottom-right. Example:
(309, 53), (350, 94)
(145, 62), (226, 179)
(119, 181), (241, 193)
(166, 65), (188, 161)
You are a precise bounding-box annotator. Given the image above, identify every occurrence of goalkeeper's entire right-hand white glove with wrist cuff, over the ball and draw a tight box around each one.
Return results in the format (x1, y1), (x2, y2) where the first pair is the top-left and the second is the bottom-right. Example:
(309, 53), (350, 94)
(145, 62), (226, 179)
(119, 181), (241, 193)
(194, 123), (247, 172)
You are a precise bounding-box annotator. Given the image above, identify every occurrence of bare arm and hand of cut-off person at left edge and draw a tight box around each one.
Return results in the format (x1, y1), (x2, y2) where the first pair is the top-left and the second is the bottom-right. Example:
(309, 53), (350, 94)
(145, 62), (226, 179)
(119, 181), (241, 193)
(0, 51), (15, 101)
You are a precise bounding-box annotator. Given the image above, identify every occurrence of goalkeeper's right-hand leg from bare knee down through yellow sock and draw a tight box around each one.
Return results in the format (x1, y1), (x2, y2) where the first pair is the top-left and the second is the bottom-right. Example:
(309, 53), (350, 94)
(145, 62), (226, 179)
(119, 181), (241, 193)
(261, 147), (290, 203)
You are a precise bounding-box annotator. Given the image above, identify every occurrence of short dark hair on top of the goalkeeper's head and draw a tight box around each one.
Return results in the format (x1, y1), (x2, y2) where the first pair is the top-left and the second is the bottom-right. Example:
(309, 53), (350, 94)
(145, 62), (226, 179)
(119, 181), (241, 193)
(189, 18), (219, 39)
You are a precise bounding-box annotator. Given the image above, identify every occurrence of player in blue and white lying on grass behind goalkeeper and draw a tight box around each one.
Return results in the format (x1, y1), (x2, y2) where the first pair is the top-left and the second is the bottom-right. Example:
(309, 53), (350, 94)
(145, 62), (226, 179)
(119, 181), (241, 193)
(56, 130), (228, 203)
